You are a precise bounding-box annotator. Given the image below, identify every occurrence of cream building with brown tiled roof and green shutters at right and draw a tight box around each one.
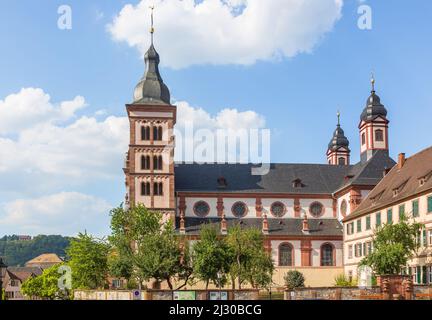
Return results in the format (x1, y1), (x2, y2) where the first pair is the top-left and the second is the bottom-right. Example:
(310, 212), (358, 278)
(344, 147), (432, 284)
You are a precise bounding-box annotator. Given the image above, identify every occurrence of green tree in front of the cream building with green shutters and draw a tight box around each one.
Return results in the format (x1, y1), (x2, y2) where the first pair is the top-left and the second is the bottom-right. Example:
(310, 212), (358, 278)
(360, 216), (423, 275)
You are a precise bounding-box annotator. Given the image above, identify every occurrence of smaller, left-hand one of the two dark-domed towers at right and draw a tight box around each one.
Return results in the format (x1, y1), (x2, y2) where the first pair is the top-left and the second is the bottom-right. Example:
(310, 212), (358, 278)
(327, 112), (351, 166)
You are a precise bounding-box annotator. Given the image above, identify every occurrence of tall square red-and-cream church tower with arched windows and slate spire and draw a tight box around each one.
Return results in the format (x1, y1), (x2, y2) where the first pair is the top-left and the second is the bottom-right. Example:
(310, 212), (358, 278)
(124, 8), (177, 218)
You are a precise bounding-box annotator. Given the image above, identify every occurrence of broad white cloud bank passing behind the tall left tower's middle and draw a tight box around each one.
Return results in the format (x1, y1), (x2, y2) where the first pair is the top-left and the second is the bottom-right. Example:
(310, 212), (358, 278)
(0, 88), (265, 235)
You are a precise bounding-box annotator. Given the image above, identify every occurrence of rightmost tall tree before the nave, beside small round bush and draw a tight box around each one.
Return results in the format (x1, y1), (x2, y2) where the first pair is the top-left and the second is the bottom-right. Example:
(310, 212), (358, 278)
(226, 224), (273, 289)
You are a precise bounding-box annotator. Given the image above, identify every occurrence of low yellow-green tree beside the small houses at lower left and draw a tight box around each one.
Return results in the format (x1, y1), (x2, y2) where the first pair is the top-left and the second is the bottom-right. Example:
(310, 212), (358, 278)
(21, 264), (70, 300)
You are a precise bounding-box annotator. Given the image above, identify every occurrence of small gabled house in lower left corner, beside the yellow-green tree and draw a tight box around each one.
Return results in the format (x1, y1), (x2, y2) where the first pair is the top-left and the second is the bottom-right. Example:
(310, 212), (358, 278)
(3, 267), (43, 300)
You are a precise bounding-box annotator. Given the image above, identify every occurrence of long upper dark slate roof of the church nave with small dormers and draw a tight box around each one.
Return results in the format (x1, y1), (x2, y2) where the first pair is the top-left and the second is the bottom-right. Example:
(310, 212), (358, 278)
(175, 151), (395, 194)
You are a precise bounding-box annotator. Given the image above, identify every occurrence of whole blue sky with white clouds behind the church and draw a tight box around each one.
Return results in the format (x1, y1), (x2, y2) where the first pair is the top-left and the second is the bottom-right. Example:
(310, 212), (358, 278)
(0, 0), (432, 236)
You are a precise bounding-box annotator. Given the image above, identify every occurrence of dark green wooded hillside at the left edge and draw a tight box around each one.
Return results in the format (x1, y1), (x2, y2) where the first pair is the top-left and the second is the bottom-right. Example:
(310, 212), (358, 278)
(0, 235), (71, 266)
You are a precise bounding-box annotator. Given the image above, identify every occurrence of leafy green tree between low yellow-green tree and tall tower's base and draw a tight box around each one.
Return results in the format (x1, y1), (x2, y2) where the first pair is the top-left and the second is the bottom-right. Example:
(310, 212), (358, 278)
(66, 233), (110, 289)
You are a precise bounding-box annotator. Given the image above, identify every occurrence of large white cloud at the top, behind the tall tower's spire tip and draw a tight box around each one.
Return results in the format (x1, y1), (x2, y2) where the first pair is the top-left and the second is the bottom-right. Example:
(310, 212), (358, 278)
(108, 0), (343, 68)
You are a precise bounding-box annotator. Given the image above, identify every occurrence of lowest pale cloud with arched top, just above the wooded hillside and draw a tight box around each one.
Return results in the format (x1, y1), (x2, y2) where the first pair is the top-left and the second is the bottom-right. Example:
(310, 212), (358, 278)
(0, 192), (111, 236)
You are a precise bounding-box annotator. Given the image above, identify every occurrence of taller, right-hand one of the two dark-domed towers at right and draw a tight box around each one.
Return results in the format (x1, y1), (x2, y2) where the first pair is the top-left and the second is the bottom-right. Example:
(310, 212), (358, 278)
(359, 76), (389, 162)
